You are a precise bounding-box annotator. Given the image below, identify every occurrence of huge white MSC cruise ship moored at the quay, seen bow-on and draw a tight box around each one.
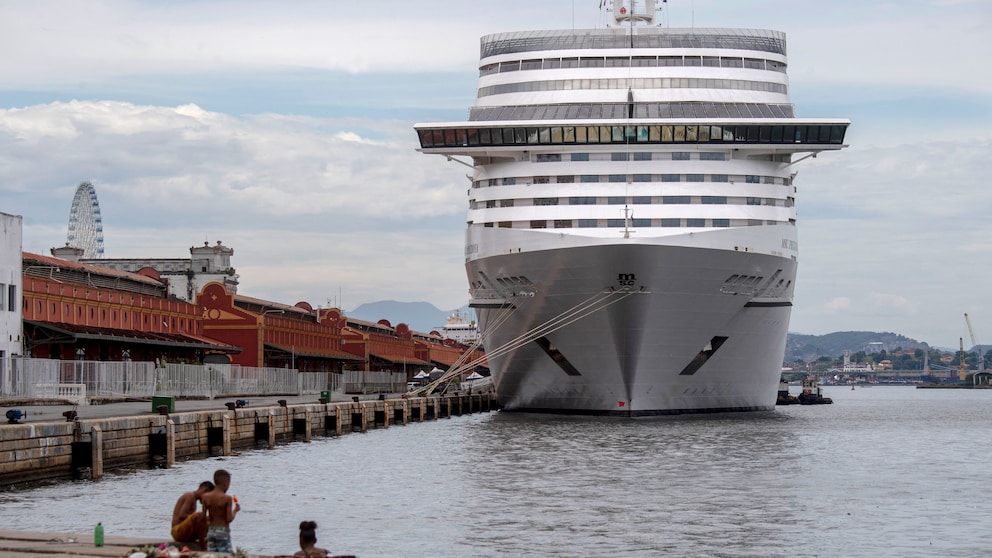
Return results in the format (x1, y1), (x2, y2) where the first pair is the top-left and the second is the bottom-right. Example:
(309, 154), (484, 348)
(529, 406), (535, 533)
(415, 0), (850, 416)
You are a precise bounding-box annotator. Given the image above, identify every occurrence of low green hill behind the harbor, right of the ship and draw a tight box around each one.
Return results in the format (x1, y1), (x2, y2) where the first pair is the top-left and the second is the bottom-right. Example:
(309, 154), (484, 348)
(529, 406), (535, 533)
(785, 331), (930, 362)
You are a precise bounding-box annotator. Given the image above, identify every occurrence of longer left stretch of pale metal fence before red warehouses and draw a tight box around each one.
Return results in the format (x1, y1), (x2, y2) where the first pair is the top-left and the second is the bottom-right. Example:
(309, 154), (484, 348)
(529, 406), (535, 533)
(0, 358), (342, 399)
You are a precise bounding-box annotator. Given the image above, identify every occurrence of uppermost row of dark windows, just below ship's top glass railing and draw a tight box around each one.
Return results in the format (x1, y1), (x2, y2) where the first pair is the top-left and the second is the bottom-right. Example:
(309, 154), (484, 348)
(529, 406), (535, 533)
(479, 56), (785, 76)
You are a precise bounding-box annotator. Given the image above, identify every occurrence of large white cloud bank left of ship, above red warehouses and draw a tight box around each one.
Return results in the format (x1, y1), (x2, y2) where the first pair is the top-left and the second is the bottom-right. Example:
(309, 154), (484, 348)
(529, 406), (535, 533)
(0, 101), (467, 309)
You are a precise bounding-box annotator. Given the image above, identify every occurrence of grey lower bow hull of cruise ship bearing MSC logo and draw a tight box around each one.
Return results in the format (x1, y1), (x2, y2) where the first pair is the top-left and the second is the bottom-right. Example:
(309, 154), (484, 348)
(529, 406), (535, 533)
(467, 226), (795, 416)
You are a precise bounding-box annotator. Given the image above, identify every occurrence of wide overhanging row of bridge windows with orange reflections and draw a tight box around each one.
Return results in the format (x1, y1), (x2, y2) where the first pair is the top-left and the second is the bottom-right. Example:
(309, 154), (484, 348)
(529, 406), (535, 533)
(417, 124), (847, 148)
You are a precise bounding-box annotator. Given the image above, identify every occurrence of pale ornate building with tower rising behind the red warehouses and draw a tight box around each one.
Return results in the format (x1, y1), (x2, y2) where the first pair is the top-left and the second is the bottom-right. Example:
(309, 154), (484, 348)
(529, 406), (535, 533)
(52, 240), (238, 302)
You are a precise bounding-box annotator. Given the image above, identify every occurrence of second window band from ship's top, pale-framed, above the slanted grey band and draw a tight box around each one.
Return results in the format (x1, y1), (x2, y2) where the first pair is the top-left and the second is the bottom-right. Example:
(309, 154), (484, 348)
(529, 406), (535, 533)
(477, 78), (789, 98)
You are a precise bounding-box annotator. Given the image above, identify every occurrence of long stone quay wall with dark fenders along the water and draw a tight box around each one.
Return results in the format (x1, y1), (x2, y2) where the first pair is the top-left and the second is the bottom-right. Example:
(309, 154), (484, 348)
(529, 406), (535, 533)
(0, 394), (497, 487)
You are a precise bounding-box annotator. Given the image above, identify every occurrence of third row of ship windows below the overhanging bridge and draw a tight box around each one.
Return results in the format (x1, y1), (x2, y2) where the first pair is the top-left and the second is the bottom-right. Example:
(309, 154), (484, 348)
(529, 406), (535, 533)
(469, 195), (795, 209)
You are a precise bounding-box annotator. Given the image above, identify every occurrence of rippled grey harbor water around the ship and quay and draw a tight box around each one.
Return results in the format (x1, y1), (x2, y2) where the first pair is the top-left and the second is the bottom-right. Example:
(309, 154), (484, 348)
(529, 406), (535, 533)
(0, 386), (992, 558)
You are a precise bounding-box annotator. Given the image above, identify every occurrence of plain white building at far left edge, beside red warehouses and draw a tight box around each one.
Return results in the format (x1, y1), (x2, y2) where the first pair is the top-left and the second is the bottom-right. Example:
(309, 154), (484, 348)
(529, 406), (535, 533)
(0, 213), (23, 394)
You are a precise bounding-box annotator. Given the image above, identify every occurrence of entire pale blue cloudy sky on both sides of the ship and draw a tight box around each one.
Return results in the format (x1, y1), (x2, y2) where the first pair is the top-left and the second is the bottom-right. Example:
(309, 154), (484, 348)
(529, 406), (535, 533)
(0, 0), (992, 348)
